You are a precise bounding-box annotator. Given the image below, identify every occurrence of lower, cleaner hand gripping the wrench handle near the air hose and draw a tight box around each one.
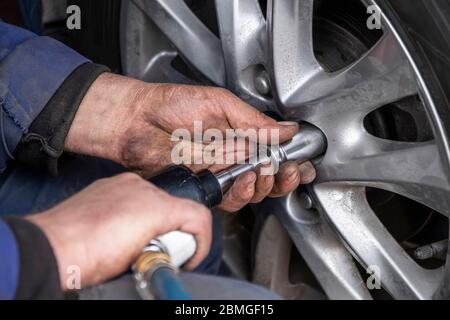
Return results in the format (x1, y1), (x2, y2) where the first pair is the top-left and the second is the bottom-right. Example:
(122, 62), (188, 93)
(28, 173), (211, 290)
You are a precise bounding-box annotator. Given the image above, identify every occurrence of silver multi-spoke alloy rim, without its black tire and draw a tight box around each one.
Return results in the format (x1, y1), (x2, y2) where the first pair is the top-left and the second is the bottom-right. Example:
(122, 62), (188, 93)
(121, 0), (450, 299)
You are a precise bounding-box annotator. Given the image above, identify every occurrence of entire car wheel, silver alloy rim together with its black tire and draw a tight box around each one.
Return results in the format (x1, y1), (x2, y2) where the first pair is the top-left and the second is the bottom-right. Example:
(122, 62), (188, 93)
(75, 0), (450, 299)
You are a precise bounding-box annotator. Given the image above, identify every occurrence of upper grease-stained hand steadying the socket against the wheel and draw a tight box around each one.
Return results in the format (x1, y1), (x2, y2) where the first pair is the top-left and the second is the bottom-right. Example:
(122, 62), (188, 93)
(66, 74), (315, 211)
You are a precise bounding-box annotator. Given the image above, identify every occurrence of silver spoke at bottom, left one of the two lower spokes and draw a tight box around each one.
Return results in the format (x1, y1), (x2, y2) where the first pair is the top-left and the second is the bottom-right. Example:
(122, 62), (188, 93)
(262, 192), (371, 300)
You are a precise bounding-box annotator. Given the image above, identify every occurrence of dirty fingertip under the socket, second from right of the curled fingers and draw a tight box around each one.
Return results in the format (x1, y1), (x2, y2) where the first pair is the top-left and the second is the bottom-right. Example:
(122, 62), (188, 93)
(269, 162), (301, 198)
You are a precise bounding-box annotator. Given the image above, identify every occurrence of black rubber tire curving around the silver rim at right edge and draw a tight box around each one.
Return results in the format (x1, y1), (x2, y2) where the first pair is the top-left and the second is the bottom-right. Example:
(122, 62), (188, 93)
(377, 0), (450, 299)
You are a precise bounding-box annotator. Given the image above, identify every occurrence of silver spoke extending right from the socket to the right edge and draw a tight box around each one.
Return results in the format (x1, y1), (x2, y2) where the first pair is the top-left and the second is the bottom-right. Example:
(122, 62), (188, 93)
(319, 135), (450, 216)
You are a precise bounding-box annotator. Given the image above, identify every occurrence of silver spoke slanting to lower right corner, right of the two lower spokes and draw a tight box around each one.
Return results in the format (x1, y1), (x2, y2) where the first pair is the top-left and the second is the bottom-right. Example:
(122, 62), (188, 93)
(315, 183), (443, 299)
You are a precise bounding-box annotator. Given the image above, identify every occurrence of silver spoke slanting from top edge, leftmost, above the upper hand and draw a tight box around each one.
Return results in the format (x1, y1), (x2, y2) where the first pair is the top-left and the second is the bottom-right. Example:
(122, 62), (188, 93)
(133, 0), (226, 86)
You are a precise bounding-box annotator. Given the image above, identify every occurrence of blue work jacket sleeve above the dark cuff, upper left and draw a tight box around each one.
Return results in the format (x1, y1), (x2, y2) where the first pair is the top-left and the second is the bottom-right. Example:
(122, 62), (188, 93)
(0, 21), (88, 169)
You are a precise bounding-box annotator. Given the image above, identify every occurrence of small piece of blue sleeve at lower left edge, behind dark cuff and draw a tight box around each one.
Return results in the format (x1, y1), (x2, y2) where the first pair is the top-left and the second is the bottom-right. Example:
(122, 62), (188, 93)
(0, 220), (20, 300)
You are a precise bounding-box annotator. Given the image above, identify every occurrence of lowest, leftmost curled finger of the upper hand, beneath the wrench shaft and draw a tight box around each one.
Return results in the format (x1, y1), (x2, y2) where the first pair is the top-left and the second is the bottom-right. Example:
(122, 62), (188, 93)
(219, 172), (256, 212)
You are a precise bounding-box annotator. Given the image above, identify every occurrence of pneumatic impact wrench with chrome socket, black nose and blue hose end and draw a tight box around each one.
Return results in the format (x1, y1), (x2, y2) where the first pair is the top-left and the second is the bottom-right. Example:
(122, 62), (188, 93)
(133, 124), (327, 300)
